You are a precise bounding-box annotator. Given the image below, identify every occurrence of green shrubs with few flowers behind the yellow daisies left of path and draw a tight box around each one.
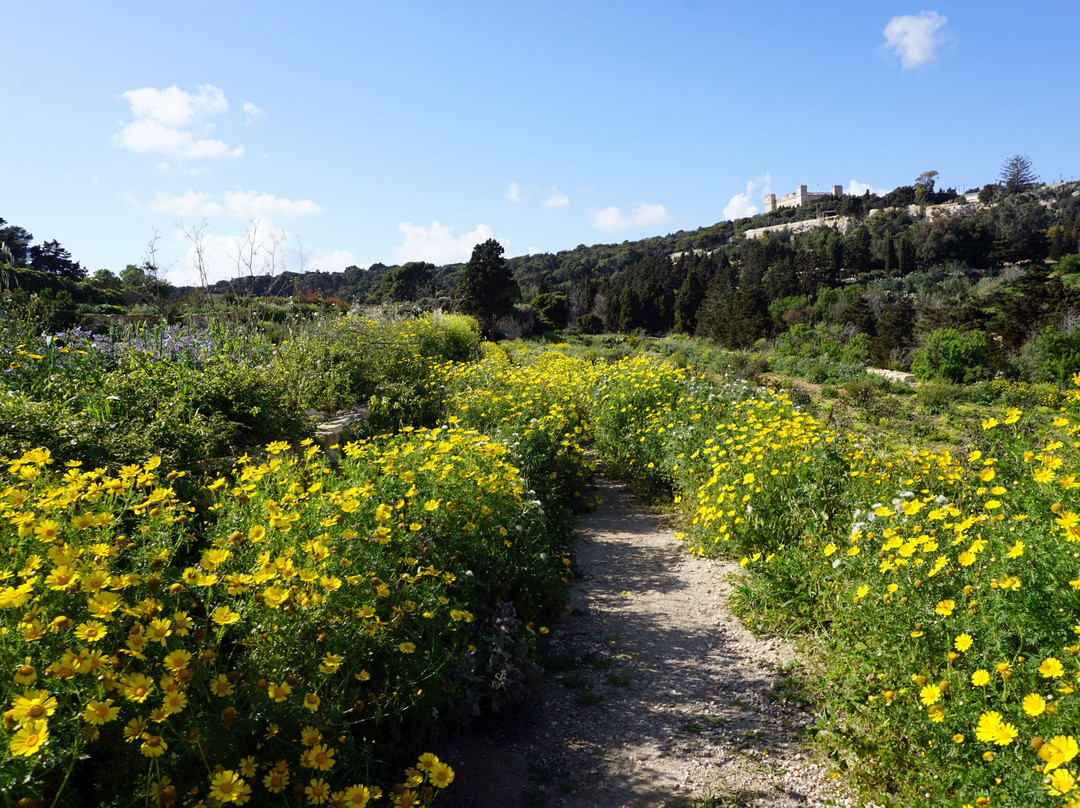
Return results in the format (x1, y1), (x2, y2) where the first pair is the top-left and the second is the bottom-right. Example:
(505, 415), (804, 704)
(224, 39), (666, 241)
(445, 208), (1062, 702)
(0, 314), (478, 468)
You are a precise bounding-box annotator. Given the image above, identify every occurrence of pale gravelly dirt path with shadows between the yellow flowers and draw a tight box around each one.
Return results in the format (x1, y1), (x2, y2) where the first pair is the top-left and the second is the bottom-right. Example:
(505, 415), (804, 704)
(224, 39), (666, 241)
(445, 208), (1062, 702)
(443, 480), (854, 808)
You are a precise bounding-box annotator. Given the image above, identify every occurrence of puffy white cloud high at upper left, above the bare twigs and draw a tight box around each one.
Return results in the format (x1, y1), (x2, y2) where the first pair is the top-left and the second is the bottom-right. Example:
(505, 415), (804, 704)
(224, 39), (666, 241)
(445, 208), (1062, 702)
(112, 84), (244, 160)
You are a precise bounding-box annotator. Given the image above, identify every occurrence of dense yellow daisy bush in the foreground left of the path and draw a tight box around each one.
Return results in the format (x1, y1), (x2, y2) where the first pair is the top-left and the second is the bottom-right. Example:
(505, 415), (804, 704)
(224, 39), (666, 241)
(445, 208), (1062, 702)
(0, 428), (569, 808)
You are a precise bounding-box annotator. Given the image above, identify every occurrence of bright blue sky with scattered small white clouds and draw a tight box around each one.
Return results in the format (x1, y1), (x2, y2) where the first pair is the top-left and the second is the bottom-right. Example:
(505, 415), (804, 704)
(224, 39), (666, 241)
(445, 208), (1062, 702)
(0, 0), (1080, 284)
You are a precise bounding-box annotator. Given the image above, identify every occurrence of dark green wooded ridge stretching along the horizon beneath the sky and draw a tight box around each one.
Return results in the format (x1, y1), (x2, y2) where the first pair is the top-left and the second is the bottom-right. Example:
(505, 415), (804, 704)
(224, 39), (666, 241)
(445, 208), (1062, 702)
(6, 165), (1080, 380)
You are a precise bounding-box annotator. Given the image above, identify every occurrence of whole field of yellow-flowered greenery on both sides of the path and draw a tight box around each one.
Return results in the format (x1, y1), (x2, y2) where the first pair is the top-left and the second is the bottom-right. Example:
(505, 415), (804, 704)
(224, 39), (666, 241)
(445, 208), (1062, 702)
(0, 278), (1080, 806)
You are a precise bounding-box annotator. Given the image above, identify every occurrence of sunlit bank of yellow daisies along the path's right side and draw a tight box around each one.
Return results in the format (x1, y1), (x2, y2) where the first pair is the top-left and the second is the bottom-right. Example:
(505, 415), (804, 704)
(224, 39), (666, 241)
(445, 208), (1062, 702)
(593, 347), (1080, 806)
